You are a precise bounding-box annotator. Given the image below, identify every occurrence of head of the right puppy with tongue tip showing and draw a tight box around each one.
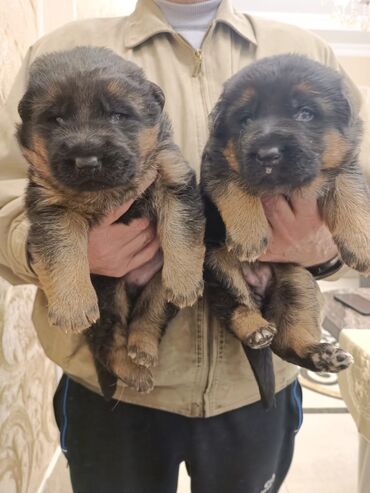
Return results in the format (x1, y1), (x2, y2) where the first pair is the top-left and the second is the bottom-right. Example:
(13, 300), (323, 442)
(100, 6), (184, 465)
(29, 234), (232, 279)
(211, 55), (359, 194)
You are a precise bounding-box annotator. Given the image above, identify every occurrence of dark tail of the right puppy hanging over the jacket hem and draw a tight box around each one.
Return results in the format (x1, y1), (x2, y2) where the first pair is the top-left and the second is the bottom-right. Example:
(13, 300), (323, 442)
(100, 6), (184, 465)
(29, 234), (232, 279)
(243, 345), (275, 409)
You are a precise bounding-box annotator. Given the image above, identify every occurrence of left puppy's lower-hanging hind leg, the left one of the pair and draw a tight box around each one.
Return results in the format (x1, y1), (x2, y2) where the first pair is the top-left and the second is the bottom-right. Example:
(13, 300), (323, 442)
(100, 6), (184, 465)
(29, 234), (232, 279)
(86, 276), (153, 399)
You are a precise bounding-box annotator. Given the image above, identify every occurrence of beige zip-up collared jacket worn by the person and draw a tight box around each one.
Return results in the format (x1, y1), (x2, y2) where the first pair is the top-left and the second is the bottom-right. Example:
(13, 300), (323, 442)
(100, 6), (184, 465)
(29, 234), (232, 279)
(0, 0), (366, 416)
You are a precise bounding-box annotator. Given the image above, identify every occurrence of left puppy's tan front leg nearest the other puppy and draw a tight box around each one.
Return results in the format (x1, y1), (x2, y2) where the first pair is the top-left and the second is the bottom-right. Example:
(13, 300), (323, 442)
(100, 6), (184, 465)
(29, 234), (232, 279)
(156, 144), (205, 308)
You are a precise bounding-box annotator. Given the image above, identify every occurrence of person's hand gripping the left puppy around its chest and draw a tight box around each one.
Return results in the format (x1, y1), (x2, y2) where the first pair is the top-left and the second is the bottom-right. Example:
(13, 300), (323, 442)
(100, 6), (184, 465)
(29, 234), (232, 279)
(87, 178), (163, 285)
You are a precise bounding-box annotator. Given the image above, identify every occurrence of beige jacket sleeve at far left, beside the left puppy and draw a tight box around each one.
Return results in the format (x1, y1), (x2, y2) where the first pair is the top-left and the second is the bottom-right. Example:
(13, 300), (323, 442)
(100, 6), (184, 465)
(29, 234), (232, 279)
(0, 50), (37, 284)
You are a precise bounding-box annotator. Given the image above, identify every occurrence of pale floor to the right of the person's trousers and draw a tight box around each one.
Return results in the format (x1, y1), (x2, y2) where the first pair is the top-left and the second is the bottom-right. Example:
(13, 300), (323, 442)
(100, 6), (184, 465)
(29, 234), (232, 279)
(280, 390), (357, 493)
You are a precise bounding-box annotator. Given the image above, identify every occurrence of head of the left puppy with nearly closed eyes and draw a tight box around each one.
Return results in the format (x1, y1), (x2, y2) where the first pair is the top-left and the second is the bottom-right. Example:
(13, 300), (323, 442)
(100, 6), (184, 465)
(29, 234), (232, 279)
(18, 47), (164, 191)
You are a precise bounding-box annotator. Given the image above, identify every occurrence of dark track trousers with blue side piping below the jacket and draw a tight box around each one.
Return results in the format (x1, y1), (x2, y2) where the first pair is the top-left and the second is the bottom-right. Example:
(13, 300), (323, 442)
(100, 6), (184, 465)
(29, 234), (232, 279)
(54, 376), (302, 493)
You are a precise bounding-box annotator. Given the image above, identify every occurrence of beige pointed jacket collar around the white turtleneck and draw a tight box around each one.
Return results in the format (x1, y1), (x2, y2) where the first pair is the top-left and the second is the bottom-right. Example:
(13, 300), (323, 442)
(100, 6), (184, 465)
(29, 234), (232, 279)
(125, 0), (257, 48)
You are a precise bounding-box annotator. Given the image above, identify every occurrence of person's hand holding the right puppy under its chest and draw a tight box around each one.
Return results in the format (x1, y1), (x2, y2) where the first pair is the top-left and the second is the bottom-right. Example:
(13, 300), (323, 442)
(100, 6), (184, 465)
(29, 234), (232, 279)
(258, 193), (338, 267)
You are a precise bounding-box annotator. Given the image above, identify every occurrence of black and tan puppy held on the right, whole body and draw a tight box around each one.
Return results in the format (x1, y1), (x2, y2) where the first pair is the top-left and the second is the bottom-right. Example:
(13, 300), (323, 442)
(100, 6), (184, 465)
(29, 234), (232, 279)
(201, 55), (370, 404)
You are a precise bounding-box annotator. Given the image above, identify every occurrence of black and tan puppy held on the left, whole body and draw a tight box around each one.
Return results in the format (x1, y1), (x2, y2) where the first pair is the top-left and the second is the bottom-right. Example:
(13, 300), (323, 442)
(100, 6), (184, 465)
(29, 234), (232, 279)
(18, 47), (204, 395)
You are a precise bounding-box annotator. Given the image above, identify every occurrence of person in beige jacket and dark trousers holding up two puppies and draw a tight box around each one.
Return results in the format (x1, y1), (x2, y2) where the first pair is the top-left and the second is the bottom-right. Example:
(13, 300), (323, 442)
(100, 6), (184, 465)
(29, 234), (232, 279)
(0, 0), (365, 493)
